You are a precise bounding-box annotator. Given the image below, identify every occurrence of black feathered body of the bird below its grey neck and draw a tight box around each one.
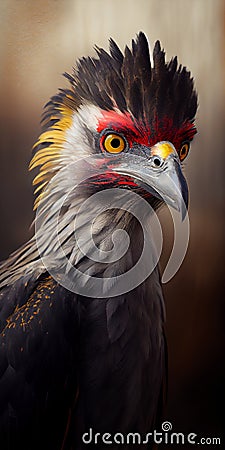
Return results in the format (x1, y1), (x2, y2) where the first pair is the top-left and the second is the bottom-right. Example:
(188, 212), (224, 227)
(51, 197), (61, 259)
(0, 271), (166, 450)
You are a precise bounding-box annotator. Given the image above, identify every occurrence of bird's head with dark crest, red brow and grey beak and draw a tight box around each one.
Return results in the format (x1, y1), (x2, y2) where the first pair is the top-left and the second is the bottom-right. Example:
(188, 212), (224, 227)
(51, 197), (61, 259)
(30, 32), (197, 220)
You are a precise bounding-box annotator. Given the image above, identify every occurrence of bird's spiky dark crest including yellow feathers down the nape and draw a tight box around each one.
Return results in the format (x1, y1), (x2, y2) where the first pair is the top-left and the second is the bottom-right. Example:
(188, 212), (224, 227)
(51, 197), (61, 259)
(30, 32), (197, 208)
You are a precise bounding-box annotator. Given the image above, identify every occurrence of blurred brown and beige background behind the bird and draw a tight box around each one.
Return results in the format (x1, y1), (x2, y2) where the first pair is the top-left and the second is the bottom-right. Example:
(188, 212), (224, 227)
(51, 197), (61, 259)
(0, 0), (225, 449)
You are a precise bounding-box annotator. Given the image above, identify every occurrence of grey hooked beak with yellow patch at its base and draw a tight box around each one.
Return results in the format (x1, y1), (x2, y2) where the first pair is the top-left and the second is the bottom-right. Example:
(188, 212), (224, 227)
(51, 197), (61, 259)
(112, 141), (188, 220)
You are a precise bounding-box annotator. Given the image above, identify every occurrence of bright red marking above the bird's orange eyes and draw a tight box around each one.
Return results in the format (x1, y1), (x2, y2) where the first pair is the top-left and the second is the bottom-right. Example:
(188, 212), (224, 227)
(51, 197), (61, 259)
(97, 110), (197, 151)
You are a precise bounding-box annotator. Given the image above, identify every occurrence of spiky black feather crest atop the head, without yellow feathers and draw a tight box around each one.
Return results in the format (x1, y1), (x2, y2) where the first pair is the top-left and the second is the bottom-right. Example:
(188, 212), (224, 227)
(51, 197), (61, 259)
(44, 32), (197, 138)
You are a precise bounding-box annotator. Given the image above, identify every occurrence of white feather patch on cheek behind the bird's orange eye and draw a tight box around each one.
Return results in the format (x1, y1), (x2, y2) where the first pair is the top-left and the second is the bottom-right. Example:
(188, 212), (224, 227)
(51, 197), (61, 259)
(61, 105), (102, 165)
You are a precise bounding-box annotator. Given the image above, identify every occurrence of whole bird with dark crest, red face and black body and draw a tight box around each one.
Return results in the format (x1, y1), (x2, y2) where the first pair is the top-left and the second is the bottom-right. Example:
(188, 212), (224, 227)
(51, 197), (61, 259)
(0, 32), (198, 450)
